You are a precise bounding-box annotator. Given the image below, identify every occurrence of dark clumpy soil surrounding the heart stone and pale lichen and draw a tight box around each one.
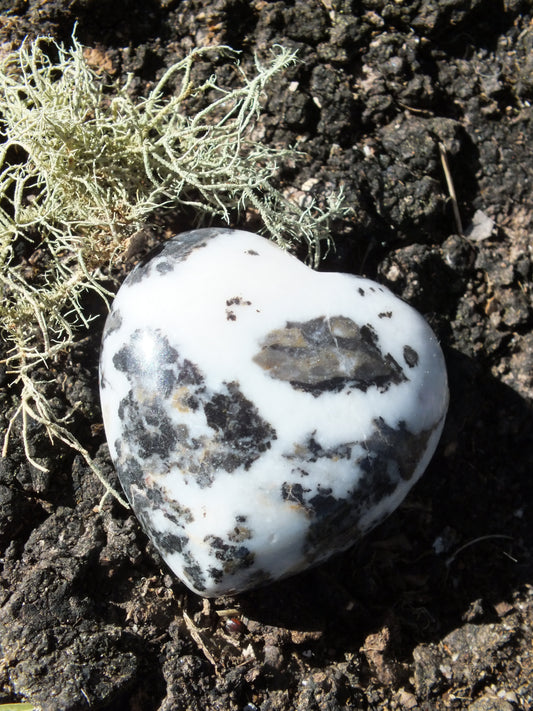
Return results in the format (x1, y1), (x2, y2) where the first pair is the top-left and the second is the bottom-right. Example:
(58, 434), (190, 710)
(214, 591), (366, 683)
(0, 0), (533, 711)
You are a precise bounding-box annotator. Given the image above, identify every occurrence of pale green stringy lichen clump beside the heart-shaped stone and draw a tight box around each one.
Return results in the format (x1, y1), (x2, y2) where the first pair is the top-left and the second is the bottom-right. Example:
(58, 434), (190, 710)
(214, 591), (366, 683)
(0, 32), (348, 500)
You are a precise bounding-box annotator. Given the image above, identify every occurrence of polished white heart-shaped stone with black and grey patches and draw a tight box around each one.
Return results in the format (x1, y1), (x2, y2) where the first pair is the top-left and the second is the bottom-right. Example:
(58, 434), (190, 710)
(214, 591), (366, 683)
(100, 229), (448, 596)
